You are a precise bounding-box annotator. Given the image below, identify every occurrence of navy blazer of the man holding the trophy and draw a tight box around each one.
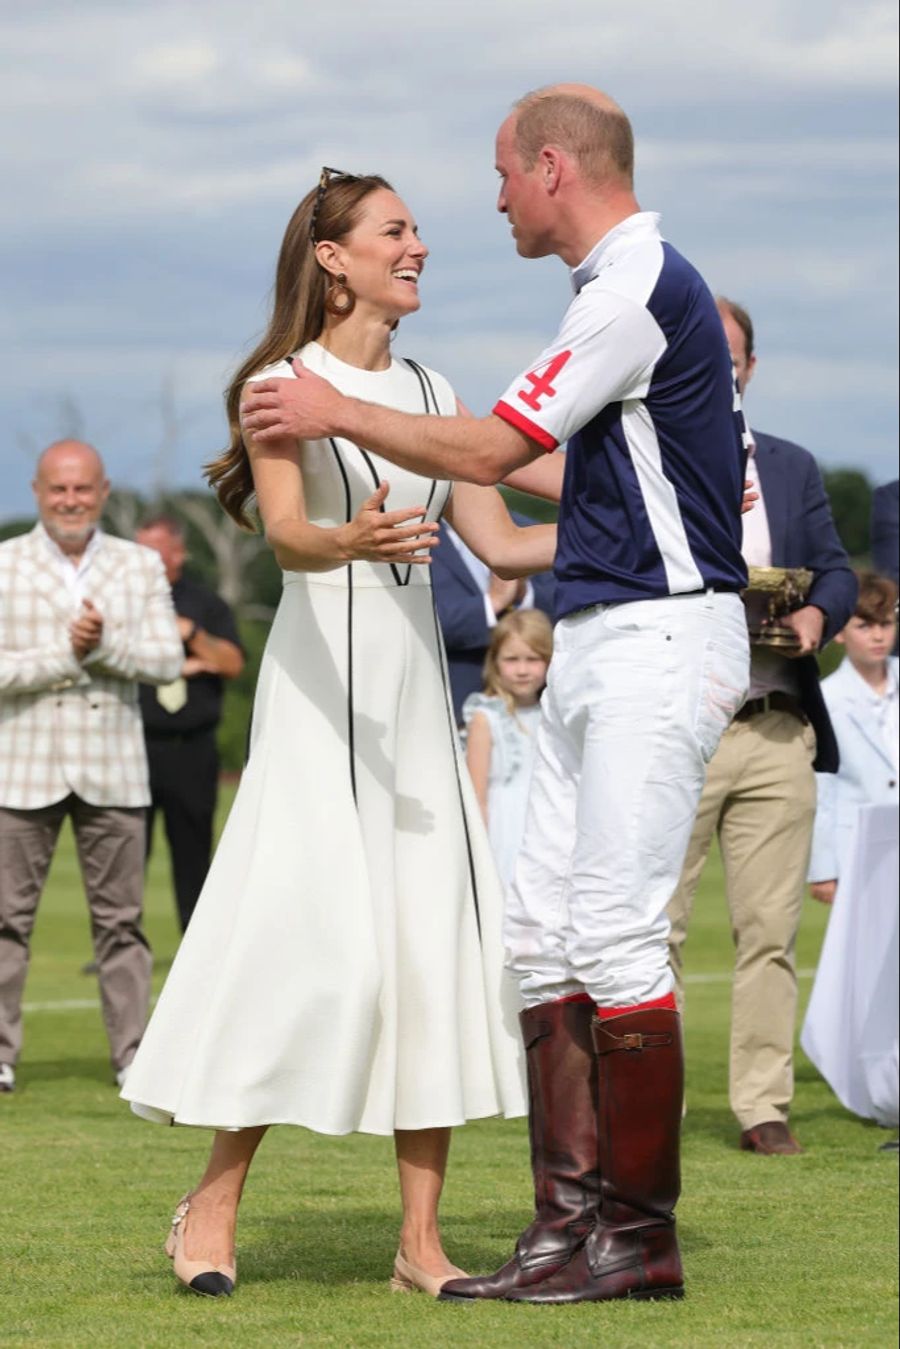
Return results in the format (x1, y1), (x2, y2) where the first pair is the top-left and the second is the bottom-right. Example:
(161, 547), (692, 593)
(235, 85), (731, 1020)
(753, 430), (857, 773)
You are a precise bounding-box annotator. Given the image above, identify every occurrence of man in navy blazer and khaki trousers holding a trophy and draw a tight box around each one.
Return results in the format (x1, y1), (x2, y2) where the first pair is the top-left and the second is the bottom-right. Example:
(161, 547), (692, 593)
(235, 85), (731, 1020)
(669, 298), (857, 1153)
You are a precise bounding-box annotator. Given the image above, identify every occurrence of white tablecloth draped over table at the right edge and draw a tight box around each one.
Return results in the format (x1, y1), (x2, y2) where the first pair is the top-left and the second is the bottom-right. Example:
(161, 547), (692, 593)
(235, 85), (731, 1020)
(800, 805), (900, 1128)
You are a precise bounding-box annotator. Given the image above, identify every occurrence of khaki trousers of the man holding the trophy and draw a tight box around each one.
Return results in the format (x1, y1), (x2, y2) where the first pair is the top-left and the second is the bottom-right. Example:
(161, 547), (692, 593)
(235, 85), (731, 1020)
(668, 712), (816, 1129)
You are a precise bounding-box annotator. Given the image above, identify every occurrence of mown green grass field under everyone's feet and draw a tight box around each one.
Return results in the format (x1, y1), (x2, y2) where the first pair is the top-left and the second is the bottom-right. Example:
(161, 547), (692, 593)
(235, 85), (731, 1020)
(0, 787), (897, 1349)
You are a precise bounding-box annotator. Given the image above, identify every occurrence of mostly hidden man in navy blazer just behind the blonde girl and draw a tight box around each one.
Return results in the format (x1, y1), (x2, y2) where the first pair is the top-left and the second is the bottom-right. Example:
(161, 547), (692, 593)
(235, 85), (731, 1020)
(432, 513), (555, 726)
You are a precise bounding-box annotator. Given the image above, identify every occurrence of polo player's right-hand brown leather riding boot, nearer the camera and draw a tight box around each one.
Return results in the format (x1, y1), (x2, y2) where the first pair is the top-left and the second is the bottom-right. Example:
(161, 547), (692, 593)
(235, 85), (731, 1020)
(507, 1008), (684, 1303)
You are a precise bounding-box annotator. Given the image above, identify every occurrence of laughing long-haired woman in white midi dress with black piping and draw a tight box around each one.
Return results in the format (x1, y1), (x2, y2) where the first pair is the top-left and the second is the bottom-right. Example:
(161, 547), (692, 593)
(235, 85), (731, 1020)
(123, 170), (555, 1295)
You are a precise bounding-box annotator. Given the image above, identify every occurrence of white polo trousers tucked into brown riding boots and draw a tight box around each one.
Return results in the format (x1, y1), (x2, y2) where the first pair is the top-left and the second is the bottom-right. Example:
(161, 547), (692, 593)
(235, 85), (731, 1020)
(505, 591), (749, 1006)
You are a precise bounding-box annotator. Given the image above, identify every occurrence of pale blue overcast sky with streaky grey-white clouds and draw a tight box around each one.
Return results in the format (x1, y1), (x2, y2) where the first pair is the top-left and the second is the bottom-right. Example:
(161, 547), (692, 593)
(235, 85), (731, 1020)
(0, 0), (897, 518)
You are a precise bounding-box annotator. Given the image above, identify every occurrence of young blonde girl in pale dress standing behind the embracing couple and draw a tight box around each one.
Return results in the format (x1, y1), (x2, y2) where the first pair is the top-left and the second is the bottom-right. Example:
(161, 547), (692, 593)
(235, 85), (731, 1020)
(463, 608), (553, 889)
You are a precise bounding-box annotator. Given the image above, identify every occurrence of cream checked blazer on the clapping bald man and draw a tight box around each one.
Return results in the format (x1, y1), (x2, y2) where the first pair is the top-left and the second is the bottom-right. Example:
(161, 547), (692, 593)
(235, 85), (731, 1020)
(0, 525), (184, 811)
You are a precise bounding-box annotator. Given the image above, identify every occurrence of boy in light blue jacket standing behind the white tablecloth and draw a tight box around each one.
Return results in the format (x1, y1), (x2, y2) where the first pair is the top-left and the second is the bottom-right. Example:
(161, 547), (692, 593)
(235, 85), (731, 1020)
(808, 572), (900, 904)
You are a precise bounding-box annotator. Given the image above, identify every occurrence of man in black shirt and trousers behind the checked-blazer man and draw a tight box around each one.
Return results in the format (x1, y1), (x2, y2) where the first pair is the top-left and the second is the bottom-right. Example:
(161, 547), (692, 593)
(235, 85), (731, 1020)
(135, 515), (244, 931)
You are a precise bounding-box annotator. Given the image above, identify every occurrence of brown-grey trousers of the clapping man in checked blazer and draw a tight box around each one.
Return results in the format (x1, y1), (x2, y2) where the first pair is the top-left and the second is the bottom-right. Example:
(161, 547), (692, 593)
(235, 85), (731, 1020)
(0, 795), (152, 1070)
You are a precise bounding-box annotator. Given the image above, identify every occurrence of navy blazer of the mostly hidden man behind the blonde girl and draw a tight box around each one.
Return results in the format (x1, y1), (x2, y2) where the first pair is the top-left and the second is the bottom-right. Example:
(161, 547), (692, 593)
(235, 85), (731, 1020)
(430, 513), (556, 726)
